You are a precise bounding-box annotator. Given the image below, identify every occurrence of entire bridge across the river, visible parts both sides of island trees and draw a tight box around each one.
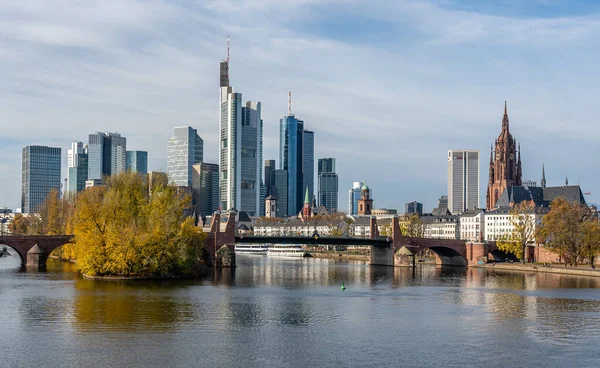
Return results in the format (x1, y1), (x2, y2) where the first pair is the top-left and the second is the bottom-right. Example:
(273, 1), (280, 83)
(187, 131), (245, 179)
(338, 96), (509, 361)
(0, 213), (498, 269)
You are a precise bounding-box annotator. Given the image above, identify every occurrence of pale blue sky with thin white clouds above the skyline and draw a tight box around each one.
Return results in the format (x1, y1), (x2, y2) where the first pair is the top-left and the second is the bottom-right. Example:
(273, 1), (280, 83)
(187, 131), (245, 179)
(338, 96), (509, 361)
(0, 0), (600, 212)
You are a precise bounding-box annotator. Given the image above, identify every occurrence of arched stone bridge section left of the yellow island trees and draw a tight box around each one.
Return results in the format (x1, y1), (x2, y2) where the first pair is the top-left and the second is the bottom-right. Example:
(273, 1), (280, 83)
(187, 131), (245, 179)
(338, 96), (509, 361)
(0, 235), (73, 269)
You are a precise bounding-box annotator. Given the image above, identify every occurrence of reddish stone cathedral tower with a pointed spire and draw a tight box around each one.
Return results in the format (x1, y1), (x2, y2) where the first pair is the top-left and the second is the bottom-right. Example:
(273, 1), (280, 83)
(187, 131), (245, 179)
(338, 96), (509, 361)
(486, 101), (522, 211)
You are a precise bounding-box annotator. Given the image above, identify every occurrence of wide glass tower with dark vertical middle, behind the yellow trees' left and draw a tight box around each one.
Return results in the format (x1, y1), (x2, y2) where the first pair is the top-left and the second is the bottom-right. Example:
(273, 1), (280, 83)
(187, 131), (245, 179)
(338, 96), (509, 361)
(88, 132), (127, 180)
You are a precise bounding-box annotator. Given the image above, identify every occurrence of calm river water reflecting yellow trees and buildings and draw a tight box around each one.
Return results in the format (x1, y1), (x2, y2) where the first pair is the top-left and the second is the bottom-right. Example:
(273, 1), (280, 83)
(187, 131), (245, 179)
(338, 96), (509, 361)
(0, 250), (600, 367)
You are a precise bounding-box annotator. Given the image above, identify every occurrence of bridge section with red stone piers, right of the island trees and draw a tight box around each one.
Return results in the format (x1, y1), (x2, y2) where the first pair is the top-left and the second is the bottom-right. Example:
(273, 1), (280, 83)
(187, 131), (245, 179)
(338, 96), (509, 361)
(205, 214), (498, 266)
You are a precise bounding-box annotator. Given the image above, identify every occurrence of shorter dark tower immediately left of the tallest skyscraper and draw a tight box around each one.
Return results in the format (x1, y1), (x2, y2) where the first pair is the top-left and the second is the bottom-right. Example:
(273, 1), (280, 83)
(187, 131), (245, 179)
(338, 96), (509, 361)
(192, 162), (219, 216)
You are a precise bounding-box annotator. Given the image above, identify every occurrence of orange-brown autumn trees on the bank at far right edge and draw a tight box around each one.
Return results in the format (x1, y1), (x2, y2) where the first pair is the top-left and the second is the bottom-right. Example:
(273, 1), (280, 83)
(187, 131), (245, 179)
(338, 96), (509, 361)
(542, 197), (600, 266)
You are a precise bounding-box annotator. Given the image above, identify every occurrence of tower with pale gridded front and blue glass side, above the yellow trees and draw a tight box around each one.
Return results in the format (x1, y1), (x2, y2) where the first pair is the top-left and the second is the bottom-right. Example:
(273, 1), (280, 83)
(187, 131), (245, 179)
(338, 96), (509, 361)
(167, 126), (204, 187)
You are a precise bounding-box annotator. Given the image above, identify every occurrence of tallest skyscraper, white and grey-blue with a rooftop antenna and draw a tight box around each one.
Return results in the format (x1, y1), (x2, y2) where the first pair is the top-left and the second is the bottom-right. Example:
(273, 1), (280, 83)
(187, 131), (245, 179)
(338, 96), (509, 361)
(219, 40), (264, 216)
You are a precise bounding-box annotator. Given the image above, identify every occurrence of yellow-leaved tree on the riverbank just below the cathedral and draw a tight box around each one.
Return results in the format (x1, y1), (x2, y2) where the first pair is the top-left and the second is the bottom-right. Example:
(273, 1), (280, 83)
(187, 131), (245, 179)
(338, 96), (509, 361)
(496, 202), (539, 262)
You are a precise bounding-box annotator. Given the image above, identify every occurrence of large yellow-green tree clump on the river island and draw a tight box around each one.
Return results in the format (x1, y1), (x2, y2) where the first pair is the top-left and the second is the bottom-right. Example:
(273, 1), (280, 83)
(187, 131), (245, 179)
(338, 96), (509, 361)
(74, 172), (204, 277)
